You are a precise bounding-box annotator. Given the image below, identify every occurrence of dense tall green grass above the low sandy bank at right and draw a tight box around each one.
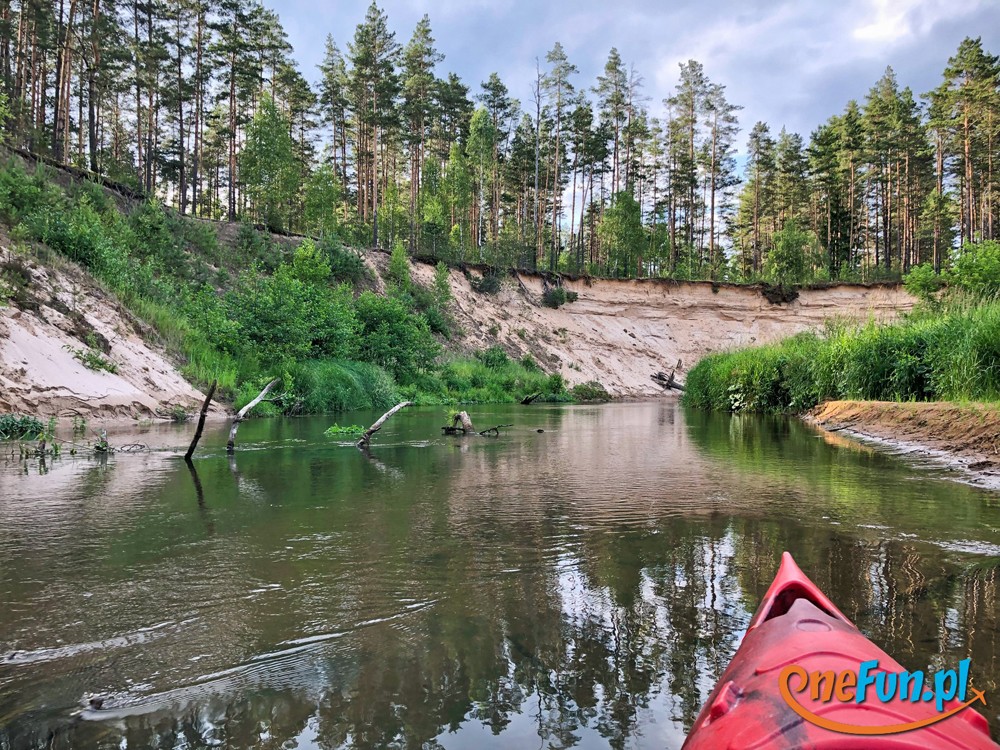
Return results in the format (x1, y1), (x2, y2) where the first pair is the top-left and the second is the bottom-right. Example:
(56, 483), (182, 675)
(684, 300), (1000, 412)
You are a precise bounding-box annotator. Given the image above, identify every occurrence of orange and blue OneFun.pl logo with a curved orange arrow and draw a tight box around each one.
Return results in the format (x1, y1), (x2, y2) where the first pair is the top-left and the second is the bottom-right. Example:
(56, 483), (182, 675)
(778, 659), (986, 735)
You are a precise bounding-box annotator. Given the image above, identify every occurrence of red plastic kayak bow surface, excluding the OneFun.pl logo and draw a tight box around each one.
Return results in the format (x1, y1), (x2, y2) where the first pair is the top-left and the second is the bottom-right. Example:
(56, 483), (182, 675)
(684, 552), (1000, 750)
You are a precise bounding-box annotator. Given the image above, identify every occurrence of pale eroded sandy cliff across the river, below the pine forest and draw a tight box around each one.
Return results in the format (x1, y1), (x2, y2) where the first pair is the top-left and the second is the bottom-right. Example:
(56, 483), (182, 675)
(404, 264), (915, 397)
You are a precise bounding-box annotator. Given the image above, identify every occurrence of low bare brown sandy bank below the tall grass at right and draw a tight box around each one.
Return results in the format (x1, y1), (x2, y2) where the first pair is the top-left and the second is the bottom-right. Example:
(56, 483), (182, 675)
(804, 401), (1000, 489)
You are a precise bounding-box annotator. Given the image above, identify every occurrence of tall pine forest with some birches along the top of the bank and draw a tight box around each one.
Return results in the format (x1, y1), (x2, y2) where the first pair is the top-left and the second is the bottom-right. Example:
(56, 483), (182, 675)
(0, 0), (1000, 283)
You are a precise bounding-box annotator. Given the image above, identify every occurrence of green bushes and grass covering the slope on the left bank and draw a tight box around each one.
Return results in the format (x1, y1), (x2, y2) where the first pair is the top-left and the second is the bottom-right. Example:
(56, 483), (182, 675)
(0, 160), (571, 414)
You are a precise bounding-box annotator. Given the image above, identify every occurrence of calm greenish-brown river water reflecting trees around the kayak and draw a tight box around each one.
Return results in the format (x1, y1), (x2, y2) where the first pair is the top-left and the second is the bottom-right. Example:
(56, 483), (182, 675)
(0, 401), (1000, 750)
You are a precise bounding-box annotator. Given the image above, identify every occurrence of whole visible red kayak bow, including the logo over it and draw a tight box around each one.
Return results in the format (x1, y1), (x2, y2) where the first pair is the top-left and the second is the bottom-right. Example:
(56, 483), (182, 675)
(683, 552), (1000, 750)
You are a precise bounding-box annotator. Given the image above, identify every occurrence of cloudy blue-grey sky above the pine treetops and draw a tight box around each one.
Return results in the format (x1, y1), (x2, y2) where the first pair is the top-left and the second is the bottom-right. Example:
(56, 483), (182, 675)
(264, 0), (1000, 150)
